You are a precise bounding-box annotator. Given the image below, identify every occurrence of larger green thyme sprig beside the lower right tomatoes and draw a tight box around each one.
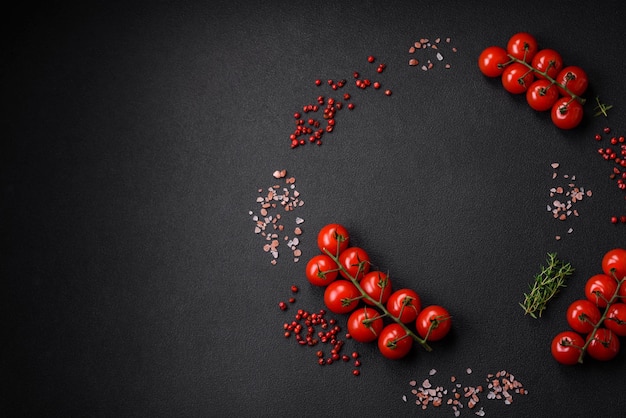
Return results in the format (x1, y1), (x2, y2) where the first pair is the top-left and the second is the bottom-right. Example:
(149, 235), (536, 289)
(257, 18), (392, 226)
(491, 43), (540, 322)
(520, 253), (574, 319)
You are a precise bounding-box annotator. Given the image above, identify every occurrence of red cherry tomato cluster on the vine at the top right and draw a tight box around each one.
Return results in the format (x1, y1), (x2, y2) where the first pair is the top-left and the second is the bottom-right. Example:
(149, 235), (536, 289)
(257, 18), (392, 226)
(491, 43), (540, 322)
(478, 32), (589, 129)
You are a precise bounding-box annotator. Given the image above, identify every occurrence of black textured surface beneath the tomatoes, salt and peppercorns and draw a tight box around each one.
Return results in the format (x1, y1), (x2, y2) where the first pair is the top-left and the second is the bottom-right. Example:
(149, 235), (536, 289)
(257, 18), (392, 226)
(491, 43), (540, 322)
(0, 1), (626, 417)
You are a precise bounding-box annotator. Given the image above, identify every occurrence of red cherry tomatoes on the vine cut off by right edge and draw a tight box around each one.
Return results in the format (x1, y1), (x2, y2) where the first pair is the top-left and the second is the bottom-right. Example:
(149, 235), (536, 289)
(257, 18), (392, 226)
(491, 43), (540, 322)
(551, 248), (626, 365)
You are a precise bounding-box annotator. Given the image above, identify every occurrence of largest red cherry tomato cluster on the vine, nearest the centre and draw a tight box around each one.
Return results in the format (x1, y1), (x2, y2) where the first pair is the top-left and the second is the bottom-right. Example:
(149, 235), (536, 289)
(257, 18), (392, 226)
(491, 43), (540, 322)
(306, 224), (452, 359)
